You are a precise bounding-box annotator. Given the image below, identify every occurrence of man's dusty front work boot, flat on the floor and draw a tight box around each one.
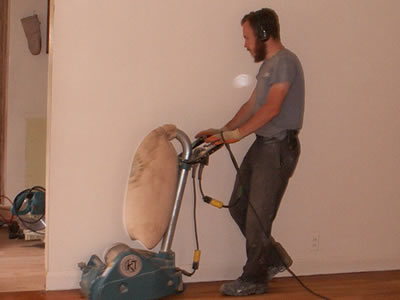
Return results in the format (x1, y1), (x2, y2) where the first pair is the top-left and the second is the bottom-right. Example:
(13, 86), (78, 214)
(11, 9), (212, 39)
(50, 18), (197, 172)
(219, 278), (267, 296)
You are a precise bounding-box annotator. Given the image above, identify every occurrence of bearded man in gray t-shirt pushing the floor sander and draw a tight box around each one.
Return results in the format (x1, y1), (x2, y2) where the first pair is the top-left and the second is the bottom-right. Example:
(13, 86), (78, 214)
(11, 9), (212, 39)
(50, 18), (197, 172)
(196, 8), (304, 296)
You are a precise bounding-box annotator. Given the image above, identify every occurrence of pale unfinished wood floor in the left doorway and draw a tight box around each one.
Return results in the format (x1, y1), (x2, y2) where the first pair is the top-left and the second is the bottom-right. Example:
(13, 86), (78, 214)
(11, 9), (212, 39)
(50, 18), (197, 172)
(0, 226), (46, 292)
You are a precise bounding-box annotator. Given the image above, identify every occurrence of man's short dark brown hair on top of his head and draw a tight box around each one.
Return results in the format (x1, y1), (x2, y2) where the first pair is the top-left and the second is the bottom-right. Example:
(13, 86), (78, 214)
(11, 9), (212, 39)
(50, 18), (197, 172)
(241, 8), (281, 40)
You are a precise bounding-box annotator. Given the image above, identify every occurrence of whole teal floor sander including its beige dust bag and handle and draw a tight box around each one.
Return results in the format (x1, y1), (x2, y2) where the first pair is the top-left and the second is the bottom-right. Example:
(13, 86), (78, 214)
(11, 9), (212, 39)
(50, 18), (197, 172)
(79, 125), (221, 300)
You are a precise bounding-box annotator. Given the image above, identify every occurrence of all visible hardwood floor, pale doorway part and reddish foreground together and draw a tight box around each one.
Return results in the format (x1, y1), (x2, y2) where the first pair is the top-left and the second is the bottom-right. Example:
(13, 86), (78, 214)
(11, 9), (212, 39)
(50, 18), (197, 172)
(0, 227), (400, 300)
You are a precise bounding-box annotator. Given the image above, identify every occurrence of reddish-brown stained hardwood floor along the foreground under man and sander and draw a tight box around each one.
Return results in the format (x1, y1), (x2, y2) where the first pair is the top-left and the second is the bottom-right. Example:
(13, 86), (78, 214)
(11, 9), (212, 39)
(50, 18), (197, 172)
(0, 271), (400, 300)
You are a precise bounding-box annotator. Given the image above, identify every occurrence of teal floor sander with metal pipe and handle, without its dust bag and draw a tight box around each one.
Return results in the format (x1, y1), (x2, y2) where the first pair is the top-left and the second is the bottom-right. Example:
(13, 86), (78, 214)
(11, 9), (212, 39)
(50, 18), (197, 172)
(79, 129), (219, 300)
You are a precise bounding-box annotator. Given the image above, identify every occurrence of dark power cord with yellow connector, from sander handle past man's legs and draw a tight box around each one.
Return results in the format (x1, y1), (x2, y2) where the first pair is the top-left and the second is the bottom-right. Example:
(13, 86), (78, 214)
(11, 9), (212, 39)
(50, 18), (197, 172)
(199, 132), (330, 300)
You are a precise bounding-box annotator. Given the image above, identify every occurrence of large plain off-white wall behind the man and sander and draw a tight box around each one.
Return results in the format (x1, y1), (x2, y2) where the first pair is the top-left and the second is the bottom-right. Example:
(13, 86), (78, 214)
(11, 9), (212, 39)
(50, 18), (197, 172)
(47, 0), (400, 289)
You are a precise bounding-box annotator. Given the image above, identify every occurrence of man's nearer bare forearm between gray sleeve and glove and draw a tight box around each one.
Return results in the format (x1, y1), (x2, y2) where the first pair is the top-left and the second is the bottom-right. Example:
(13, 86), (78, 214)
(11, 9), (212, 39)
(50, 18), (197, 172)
(238, 82), (289, 137)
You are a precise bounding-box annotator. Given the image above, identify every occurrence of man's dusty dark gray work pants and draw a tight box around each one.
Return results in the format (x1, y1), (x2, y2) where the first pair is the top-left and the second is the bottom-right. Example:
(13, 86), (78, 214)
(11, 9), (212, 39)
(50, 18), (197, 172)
(229, 134), (300, 283)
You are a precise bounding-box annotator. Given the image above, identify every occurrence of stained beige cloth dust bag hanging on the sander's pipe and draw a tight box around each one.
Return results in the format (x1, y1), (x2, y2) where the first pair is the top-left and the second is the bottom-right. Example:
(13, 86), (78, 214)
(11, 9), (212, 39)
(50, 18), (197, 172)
(123, 125), (178, 249)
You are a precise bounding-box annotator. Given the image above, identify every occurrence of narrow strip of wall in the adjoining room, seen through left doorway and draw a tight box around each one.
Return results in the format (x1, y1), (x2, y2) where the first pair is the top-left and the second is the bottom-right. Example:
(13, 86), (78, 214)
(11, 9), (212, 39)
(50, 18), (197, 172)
(5, 0), (48, 198)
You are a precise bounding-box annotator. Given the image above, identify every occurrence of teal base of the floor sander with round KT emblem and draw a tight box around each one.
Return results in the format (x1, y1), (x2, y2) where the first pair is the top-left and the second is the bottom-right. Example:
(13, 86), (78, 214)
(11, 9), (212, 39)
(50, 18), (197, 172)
(80, 244), (183, 300)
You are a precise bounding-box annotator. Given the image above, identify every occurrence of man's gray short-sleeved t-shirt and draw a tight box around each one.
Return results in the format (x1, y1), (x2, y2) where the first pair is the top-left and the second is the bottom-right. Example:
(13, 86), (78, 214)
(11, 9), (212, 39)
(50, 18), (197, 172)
(253, 48), (304, 139)
